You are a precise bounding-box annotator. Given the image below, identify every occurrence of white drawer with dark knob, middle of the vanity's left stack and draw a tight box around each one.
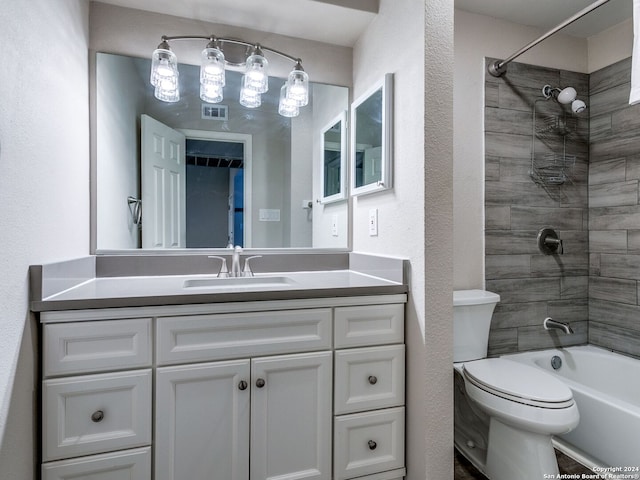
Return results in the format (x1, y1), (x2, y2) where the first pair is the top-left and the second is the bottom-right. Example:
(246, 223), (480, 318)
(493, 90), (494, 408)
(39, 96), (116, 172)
(42, 370), (151, 461)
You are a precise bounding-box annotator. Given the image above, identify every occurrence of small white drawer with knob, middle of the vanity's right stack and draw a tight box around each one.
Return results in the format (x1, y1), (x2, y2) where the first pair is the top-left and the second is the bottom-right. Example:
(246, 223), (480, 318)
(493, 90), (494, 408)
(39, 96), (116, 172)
(334, 345), (405, 415)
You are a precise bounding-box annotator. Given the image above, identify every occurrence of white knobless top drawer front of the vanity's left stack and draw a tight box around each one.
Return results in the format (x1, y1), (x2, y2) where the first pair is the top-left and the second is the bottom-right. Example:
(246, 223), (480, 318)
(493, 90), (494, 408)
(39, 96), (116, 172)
(44, 318), (151, 377)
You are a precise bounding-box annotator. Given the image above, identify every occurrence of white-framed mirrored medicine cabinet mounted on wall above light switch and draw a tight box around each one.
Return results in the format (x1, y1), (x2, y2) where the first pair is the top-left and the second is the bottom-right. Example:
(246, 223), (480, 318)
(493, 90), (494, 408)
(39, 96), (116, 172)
(351, 73), (393, 195)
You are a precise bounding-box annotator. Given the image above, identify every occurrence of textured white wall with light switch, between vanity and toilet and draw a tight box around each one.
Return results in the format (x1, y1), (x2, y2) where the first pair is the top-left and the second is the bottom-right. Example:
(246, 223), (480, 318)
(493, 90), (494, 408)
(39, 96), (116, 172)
(352, 0), (453, 480)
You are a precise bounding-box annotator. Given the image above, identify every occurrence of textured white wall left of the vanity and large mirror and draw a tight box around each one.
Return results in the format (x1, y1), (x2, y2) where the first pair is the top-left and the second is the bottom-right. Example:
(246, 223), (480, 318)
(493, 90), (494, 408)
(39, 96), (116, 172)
(0, 0), (89, 474)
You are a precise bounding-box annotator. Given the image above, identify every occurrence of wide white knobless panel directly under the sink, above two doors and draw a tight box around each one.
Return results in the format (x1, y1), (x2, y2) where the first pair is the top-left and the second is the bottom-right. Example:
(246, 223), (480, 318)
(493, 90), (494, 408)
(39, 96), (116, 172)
(156, 308), (331, 365)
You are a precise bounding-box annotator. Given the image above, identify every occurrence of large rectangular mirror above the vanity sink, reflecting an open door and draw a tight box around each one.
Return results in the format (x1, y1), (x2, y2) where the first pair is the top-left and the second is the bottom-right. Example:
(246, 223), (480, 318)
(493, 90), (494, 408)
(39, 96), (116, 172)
(92, 53), (349, 253)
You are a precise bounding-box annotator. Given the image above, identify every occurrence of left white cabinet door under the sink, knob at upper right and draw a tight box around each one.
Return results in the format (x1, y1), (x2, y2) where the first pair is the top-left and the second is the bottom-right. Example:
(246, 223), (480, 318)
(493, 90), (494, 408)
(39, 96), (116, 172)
(155, 360), (250, 480)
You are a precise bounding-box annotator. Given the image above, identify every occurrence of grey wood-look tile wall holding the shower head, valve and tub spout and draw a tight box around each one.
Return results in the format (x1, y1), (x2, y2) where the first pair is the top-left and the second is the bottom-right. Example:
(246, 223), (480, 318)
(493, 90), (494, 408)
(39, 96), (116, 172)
(485, 63), (592, 355)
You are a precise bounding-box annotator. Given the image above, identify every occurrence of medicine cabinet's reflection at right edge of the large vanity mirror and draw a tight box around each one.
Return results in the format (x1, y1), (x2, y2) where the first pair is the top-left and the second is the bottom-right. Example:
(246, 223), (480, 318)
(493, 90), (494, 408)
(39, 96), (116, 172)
(320, 111), (347, 203)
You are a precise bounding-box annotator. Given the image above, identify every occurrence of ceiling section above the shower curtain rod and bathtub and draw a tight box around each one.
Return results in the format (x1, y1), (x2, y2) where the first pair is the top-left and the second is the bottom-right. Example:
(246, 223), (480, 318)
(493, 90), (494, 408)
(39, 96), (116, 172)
(455, 0), (633, 38)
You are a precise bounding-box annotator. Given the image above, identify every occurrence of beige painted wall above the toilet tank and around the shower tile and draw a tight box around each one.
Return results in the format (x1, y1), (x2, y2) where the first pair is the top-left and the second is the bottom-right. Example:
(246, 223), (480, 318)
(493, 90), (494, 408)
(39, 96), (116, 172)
(453, 10), (587, 289)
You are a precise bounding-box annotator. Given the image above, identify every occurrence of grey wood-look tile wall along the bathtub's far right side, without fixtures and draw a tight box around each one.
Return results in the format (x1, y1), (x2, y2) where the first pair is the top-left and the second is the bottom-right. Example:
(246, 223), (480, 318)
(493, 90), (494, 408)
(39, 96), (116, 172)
(589, 59), (640, 357)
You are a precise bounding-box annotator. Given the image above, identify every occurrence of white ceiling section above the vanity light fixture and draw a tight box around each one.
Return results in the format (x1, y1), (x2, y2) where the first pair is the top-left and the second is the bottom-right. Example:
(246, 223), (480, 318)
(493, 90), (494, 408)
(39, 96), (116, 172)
(92, 0), (379, 47)
